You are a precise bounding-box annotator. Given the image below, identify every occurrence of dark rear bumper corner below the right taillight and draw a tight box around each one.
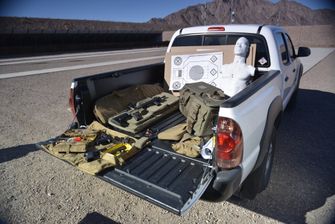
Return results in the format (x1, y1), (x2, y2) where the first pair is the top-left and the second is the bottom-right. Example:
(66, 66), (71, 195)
(204, 167), (242, 201)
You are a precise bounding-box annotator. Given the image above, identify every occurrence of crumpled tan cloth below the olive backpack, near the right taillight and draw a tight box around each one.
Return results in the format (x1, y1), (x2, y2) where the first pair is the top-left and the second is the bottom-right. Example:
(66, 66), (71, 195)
(172, 133), (201, 158)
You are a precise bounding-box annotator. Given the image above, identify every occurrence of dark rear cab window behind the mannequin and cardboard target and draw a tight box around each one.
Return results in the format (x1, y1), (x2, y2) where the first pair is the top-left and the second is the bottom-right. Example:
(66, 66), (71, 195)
(172, 34), (270, 67)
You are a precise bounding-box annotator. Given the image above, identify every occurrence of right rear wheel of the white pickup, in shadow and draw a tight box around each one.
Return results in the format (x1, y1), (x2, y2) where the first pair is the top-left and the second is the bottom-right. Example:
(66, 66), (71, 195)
(236, 128), (276, 199)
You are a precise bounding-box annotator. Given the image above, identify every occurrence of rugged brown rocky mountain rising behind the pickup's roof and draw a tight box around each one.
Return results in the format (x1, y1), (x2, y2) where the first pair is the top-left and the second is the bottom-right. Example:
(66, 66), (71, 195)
(149, 0), (335, 28)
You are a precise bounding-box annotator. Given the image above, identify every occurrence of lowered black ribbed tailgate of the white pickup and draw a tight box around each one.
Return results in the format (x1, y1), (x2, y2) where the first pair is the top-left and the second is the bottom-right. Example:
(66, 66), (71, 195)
(102, 146), (212, 214)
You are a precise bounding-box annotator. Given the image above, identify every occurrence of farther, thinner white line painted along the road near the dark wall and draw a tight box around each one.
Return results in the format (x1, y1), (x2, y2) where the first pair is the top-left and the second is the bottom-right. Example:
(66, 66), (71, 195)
(0, 48), (166, 65)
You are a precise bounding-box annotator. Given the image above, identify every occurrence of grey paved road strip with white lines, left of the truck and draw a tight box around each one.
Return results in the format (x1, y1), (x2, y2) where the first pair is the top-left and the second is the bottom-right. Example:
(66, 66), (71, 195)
(0, 48), (166, 78)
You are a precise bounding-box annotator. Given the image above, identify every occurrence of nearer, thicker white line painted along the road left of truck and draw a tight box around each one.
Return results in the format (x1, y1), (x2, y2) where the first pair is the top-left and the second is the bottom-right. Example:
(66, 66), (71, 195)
(0, 56), (164, 79)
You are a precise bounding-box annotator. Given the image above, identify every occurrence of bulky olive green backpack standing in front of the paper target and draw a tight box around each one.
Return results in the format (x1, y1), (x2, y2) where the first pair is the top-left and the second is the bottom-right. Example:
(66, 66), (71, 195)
(179, 82), (226, 137)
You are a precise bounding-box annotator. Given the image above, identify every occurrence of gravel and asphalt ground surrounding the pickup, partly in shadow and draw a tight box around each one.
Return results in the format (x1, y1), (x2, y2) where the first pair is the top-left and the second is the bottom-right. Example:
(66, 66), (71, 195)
(0, 50), (335, 223)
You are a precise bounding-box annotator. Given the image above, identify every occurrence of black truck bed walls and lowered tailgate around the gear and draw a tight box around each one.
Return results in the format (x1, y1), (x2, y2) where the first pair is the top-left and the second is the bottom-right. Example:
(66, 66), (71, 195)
(68, 64), (277, 215)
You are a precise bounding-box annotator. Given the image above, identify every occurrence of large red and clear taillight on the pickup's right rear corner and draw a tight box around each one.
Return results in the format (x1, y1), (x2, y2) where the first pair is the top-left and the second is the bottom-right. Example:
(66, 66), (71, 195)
(215, 117), (243, 169)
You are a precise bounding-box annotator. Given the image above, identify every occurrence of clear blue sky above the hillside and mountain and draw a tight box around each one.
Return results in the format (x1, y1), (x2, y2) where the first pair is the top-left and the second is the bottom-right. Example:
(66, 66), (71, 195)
(0, 0), (335, 22)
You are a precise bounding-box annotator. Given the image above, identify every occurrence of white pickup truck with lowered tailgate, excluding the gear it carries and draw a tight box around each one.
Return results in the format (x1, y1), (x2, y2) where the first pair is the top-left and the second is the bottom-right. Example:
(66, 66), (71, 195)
(40, 25), (310, 214)
